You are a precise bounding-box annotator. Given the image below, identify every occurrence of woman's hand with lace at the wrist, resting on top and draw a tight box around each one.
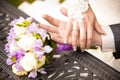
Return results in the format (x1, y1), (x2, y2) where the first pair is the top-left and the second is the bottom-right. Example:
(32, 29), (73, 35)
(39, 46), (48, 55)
(61, 6), (105, 51)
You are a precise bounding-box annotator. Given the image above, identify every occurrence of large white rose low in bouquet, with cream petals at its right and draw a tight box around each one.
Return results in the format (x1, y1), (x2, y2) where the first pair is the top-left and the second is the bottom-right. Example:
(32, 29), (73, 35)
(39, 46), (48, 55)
(20, 52), (45, 72)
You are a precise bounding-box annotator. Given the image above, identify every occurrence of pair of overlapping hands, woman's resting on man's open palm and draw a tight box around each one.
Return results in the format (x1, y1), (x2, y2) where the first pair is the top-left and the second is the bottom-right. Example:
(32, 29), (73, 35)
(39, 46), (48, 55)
(39, 7), (105, 51)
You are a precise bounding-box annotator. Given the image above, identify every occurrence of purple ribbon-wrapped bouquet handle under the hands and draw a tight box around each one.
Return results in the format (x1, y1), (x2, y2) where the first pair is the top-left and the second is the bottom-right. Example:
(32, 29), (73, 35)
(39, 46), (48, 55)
(56, 44), (73, 53)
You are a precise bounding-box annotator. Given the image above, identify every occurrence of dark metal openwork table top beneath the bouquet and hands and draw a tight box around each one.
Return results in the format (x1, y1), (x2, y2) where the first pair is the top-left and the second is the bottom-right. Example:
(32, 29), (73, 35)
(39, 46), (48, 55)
(0, 0), (120, 80)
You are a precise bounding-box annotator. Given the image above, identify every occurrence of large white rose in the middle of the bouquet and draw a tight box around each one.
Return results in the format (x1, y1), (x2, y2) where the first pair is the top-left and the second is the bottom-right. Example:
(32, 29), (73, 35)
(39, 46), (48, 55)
(17, 35), (35, 51)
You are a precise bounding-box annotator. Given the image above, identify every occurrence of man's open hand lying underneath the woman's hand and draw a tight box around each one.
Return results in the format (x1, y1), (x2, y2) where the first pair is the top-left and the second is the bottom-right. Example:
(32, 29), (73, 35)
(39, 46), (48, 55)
(39, 14), (102, 47)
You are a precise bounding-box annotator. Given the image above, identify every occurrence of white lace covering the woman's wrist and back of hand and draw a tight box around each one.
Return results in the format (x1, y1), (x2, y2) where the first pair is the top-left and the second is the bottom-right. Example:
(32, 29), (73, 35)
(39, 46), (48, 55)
(67, 0), (89, 24)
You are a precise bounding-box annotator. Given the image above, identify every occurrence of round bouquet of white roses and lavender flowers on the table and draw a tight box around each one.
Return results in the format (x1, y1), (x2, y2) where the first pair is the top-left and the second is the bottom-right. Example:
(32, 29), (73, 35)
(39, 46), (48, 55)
(5, 17), (56, 78)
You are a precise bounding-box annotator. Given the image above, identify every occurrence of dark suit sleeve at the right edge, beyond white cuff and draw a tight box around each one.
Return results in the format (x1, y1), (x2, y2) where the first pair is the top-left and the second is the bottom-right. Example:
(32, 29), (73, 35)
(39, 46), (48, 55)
(110, 24), (120, 59)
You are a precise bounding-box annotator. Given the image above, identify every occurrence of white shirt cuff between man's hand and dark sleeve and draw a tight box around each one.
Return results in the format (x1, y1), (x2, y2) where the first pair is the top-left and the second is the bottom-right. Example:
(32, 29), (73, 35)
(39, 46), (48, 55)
(102, 26), (115, 52)
